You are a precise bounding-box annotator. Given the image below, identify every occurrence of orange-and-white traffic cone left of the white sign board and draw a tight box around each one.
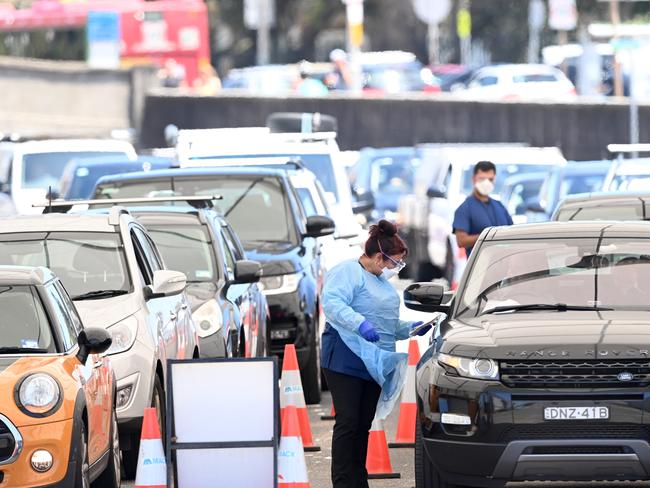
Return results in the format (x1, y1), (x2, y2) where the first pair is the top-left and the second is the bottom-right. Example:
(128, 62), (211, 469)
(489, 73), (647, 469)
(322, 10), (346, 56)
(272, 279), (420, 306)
(135, 408), (167, 488)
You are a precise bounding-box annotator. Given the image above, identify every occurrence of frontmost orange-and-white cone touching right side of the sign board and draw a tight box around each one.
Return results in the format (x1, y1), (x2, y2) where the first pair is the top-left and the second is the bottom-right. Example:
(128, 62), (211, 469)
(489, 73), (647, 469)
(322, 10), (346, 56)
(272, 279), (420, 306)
(278, 405), (309, 488)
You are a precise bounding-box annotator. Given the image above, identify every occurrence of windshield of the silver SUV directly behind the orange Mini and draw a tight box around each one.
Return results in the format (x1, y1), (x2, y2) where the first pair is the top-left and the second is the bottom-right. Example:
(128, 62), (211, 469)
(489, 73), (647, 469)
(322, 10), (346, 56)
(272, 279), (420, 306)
(0, 232), (131, 299)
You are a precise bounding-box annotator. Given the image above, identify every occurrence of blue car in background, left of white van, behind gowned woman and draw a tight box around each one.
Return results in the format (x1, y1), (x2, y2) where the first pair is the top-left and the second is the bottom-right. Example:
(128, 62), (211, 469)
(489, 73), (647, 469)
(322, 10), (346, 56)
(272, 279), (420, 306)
(350, 147), (420, 222)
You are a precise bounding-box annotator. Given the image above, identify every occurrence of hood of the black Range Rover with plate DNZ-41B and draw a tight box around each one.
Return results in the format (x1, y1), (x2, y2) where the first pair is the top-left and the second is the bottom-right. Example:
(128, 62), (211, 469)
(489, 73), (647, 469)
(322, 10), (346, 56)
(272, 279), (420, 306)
(441, 311), (650, 360)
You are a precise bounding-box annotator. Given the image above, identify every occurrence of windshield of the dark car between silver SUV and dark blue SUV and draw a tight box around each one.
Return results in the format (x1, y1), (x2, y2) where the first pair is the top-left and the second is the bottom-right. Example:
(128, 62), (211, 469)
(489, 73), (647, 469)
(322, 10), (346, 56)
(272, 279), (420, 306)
(147, 224), (218, 283)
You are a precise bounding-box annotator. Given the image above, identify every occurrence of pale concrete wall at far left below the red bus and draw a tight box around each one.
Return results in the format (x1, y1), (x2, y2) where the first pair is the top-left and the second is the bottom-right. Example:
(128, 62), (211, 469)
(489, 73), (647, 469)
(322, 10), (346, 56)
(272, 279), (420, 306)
(0, 57), (155, 140)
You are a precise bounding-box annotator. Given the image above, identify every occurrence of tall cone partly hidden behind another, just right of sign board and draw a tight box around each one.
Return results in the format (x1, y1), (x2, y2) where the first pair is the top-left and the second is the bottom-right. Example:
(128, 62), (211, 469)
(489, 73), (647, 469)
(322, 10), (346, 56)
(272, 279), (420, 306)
(280, 344), (320, 452)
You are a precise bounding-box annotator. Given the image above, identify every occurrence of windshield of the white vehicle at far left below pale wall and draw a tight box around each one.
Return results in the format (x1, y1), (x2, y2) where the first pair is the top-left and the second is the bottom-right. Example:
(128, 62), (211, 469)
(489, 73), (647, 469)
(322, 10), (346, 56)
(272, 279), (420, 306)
(22, 151), (126, 191)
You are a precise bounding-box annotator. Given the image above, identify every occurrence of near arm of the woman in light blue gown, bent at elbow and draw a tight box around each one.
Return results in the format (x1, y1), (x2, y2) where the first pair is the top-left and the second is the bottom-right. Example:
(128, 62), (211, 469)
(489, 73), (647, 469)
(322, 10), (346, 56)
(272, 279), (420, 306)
(322, 265), (366, 332)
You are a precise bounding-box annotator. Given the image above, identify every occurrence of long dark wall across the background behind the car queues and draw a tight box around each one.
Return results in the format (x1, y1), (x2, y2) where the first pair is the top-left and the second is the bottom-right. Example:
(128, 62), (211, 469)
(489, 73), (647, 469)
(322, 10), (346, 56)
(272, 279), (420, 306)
(141, 91), (650, 159)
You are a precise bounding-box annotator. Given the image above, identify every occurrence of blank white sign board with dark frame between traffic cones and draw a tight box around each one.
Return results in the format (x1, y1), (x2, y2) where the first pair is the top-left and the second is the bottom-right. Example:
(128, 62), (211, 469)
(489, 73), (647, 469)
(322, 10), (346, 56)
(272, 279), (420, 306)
(167, 358), (279, 488)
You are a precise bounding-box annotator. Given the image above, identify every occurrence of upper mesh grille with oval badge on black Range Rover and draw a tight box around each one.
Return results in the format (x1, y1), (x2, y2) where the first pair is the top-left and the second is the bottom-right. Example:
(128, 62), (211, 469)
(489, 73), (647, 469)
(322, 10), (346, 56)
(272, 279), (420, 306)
(500, 359), (650, 388)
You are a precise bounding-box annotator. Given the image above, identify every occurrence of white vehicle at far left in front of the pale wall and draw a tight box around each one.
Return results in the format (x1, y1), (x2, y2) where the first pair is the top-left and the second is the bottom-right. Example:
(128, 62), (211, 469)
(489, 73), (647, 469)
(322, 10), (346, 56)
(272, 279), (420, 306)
(1, 139), (137, 214)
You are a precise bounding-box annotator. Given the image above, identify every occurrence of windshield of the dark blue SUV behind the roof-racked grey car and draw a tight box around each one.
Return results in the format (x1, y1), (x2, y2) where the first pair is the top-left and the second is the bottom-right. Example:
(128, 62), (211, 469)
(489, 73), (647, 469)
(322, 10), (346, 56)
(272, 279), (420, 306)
(95, 175), (298, 247)
